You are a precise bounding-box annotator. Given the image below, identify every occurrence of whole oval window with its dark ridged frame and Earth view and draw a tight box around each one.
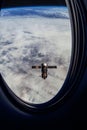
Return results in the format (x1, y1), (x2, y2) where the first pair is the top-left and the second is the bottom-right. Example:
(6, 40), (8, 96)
(0, 0), (86, 112)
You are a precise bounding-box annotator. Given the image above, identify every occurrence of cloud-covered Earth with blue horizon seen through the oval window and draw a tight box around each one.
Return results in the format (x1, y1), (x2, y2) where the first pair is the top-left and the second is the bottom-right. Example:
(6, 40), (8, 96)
(0, 6), (72, 104)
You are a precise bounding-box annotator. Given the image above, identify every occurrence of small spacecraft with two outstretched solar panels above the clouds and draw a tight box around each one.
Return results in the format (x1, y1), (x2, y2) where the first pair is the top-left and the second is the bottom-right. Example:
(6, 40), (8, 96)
(32, 63), (57, 79)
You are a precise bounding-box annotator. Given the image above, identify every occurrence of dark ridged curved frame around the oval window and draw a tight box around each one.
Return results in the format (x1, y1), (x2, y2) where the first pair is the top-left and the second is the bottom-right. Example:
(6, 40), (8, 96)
(0, 0), (86, 114)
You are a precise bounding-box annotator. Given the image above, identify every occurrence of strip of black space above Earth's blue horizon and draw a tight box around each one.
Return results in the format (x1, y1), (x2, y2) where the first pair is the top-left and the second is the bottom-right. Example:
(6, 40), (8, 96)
(0, 0), (65, 8)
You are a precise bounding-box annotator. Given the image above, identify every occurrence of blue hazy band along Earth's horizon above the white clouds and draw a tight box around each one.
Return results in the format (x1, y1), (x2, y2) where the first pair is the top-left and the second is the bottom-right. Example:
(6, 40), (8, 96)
(0, 6), (69, 19)
